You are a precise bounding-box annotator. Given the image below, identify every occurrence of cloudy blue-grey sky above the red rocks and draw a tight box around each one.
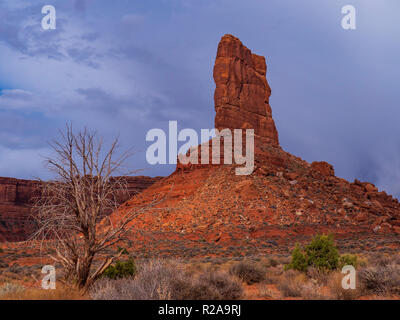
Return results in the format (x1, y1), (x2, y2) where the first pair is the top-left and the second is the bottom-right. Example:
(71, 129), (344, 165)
(0, 0), (400, 196)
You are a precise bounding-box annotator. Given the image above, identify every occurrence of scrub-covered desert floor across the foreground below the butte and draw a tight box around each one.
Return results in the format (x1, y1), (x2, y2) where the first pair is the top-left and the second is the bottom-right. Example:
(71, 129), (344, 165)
(0, 249), (400, 300)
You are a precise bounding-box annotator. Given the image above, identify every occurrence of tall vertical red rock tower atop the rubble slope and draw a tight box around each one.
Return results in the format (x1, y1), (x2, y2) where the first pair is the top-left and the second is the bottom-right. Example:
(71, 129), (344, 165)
(214, 35), (279, 145)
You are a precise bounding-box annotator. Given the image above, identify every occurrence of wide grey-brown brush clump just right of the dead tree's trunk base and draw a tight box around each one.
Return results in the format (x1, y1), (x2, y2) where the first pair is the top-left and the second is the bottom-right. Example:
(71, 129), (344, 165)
(91, 260), (243, 300)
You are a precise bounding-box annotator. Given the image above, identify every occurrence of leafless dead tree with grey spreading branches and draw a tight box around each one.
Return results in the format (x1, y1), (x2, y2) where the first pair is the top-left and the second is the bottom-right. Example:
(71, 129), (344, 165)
(33, 125), (159, 291)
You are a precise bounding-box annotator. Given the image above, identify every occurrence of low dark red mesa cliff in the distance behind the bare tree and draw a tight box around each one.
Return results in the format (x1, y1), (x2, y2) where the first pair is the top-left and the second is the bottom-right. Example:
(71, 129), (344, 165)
(0, 176), (160, 242)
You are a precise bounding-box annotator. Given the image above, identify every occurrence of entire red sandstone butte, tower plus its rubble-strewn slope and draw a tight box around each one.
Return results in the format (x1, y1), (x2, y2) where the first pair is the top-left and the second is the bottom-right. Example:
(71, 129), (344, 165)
(107, 35), (400, 258)
